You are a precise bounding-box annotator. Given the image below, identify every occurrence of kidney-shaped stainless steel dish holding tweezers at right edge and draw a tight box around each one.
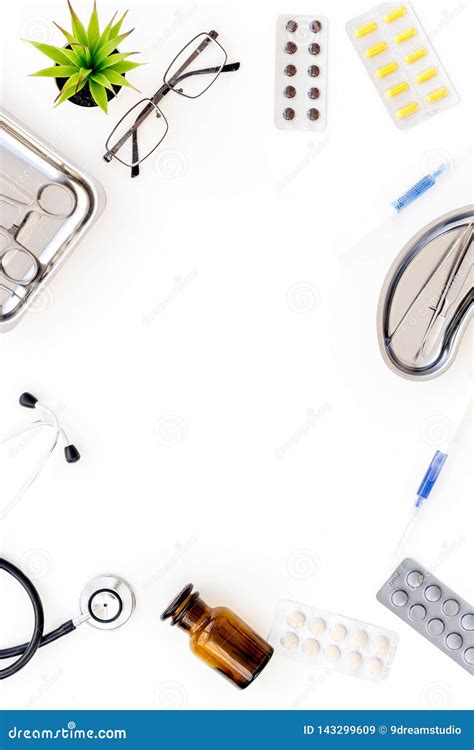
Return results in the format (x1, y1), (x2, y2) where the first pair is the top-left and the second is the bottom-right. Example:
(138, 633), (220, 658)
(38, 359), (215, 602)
(377, 205), (474, 380)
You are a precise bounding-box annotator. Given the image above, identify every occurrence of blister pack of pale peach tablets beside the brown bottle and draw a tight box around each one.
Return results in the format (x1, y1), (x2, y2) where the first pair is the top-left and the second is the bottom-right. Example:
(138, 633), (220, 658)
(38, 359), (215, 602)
(268, 599), (398, 682)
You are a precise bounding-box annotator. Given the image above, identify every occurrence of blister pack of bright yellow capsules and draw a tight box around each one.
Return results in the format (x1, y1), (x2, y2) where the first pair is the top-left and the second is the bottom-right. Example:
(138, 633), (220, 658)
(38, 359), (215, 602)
(346, 3), (458, 128)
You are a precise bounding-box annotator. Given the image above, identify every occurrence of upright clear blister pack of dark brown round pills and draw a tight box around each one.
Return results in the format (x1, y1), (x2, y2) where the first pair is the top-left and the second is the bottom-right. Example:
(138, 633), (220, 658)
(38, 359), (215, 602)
(275, 15), (328, 131)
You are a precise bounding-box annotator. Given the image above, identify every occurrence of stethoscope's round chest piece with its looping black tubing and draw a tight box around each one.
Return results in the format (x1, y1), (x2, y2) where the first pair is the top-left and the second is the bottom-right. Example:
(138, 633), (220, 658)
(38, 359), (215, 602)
(0, 557), (135, 680)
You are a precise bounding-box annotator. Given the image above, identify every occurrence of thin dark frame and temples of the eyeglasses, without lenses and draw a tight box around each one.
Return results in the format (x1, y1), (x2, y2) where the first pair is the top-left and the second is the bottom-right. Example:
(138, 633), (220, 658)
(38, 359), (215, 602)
(103, 30), (240, 177)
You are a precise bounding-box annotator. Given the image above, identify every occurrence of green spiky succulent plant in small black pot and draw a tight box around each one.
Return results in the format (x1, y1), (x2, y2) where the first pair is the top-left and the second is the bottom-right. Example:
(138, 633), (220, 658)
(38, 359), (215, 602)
(24, 0), (143, 114)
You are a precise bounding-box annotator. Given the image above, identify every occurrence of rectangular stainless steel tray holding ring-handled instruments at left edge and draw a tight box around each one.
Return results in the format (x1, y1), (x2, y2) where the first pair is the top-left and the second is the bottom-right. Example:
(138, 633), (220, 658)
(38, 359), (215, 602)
(0, 108), (105, 331)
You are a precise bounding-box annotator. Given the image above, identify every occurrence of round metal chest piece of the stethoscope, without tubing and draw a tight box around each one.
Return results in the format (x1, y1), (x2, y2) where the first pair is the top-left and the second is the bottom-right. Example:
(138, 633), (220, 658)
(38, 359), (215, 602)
(80, 574), (135, 630)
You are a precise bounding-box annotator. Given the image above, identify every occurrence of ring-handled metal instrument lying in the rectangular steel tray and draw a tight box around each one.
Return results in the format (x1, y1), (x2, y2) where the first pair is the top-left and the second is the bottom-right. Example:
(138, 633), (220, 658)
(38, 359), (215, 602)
(0, 182), (76, 286)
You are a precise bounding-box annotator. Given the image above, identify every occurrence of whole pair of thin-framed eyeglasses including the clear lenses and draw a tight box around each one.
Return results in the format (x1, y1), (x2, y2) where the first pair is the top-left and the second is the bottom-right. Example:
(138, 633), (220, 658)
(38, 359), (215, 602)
(103, 31), (240, 177)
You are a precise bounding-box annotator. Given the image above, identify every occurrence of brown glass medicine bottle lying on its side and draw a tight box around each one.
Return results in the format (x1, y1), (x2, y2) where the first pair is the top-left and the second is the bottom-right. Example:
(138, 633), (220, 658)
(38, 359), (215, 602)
(161, 583), (273, 688)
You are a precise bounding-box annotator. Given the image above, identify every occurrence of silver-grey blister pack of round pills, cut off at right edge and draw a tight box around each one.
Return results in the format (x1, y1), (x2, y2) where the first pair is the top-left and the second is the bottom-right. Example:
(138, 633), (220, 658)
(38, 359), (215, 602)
(377, 557), (474, 674)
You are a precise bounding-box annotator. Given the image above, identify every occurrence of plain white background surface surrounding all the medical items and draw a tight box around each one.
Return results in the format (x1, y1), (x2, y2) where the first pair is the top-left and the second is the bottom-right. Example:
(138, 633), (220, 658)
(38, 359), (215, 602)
(0, 0), (474, 709)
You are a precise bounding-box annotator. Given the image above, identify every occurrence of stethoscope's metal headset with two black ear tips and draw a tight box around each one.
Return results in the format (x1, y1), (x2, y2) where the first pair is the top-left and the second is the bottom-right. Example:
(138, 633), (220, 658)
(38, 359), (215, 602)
(0, 393), (81, 520)
